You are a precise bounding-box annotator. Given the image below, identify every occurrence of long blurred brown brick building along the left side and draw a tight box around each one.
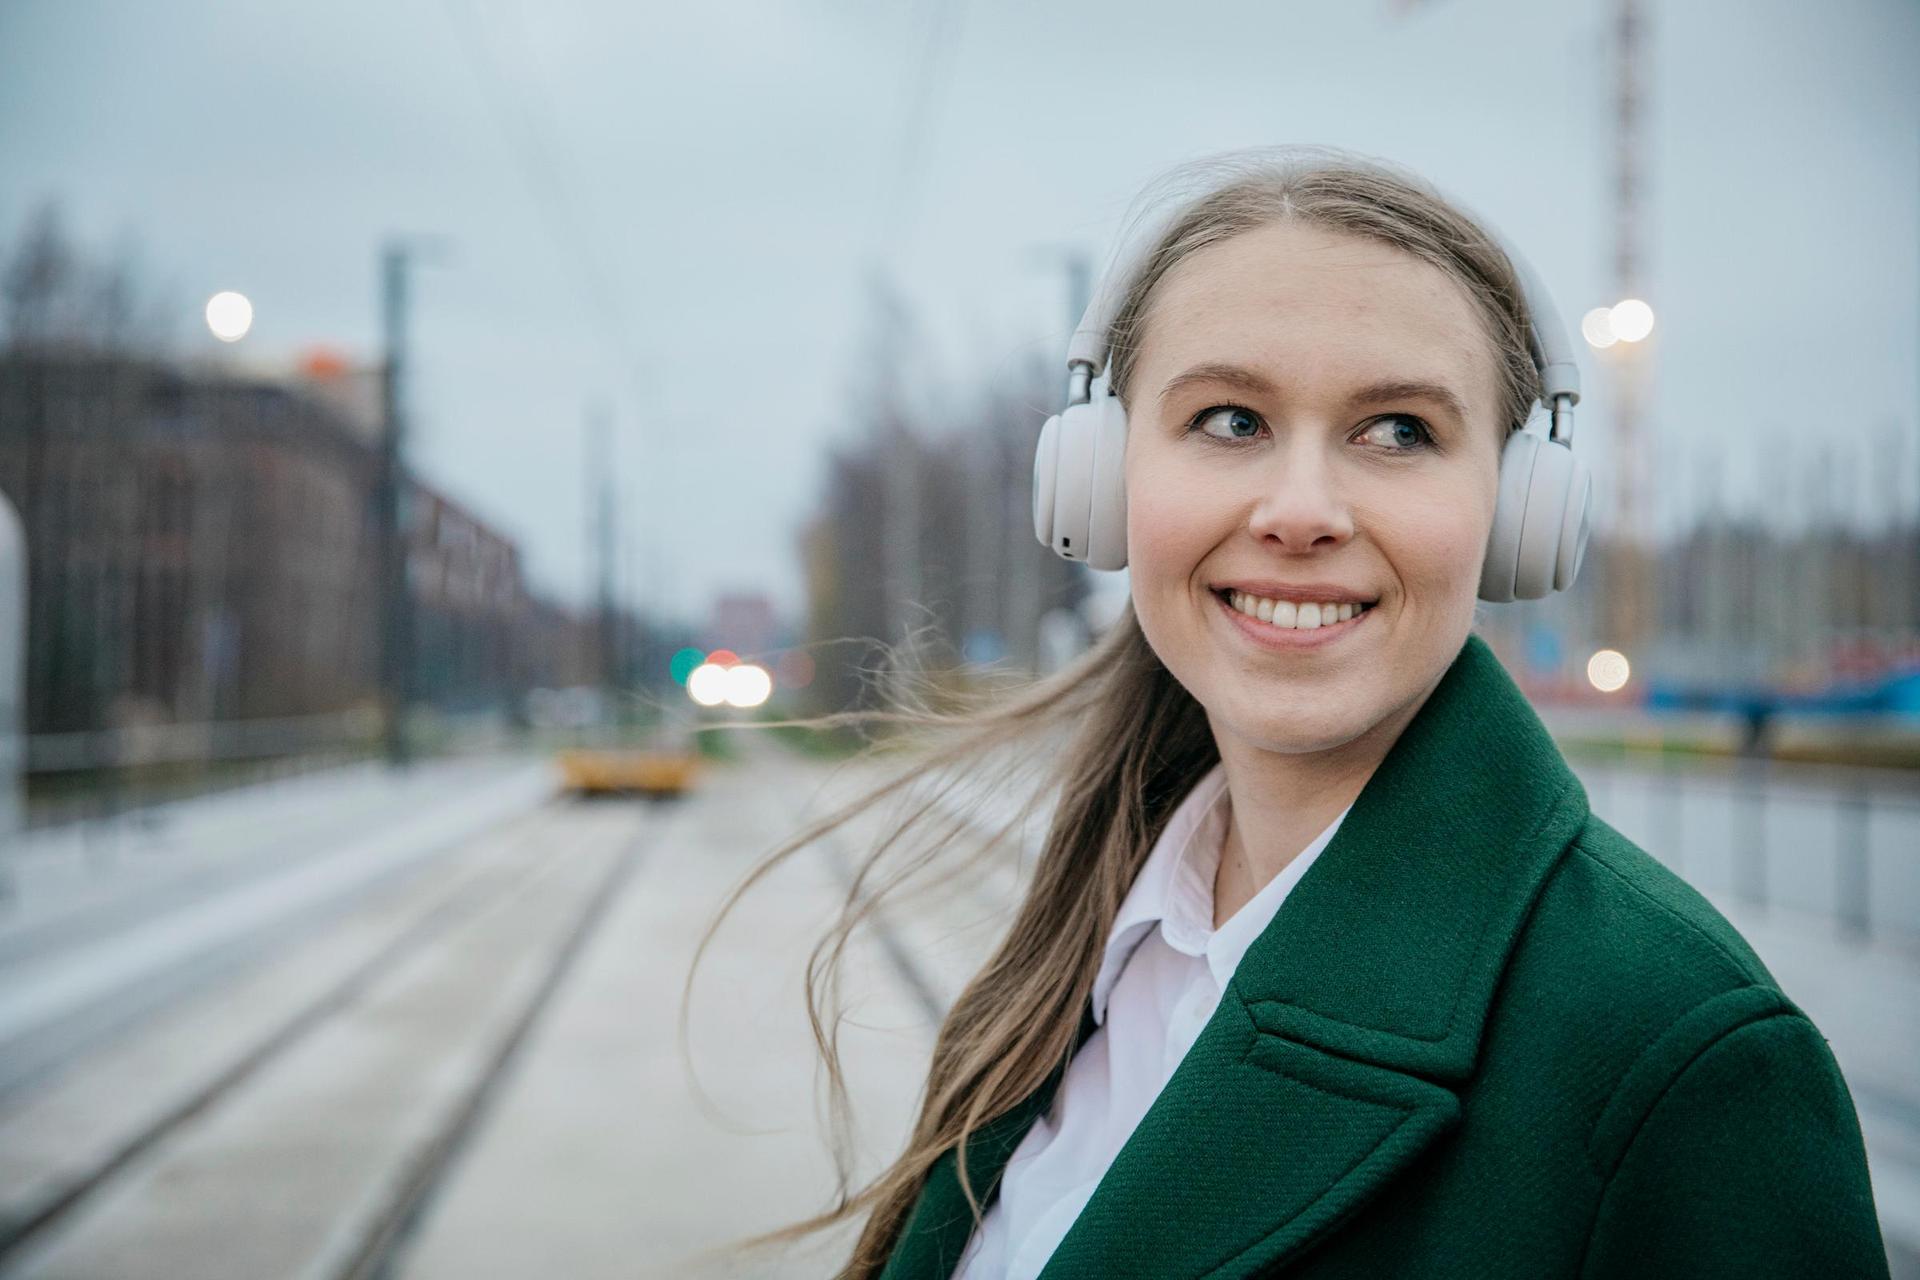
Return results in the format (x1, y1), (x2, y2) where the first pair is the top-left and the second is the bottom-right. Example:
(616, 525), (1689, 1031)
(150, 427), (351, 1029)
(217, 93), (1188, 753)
(0, 349), (572, 733)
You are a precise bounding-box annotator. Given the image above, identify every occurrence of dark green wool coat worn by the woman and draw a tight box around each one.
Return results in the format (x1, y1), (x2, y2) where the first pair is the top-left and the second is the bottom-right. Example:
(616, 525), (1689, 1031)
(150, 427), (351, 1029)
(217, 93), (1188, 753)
(885, 637), (1887, 1280)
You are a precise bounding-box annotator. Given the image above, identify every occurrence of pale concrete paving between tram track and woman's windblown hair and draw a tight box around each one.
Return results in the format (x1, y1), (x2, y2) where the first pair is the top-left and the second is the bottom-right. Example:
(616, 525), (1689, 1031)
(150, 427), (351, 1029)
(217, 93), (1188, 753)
(397, 758), (952, 1280)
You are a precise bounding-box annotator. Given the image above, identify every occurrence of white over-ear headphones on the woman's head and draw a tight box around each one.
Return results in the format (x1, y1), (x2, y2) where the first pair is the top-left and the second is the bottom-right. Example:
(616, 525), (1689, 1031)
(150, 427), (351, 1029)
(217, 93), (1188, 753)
(1033, 167), (1594, 603)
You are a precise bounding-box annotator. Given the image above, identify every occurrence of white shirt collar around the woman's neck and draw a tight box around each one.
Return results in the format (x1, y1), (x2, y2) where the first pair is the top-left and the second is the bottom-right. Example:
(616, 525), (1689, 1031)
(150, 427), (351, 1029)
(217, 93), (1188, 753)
(1092, 762), (1354, 1023)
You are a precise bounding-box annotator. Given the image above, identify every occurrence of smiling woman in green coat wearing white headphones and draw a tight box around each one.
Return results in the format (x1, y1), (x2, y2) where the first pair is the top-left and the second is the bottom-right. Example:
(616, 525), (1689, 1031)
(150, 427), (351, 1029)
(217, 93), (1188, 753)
(706, 152), (1885, 1280)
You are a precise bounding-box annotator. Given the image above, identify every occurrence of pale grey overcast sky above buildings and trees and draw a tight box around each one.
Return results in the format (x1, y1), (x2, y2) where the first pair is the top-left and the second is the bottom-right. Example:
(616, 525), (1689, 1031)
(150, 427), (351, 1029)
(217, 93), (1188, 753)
(0, 0), (1920, 616)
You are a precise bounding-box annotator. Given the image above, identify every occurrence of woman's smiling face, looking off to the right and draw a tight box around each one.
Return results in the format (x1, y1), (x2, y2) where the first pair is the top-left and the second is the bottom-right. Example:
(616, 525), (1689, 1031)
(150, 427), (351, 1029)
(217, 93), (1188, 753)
(1127, 223), (1505, 754)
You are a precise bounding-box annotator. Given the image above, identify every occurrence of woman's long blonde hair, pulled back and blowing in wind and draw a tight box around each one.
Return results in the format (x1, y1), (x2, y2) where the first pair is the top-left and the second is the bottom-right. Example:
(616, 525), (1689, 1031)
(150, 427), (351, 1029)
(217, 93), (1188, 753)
(682, 148), (1538, 1280)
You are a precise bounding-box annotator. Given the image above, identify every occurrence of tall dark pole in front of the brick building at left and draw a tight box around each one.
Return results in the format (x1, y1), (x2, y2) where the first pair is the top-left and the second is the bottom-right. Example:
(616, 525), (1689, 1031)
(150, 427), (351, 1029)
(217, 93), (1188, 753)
(376, 242), (413, 768)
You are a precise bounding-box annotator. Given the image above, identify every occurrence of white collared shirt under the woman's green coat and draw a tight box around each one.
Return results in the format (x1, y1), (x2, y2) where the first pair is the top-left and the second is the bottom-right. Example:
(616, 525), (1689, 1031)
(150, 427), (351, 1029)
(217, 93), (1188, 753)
(954, 764), (1352, 1280)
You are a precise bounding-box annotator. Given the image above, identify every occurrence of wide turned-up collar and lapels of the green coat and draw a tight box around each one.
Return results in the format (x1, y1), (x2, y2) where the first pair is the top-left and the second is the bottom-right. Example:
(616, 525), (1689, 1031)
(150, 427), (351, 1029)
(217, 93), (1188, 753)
(885, 635), (1588, 1280)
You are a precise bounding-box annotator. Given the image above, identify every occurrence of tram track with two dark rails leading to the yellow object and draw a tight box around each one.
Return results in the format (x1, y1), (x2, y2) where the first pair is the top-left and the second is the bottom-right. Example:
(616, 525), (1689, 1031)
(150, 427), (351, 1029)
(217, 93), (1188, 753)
(0, 804), (647, 1280)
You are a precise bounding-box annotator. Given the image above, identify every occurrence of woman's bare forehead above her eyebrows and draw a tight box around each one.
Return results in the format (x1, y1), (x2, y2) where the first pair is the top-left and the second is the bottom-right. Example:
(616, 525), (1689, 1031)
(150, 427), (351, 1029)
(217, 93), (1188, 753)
(1133, 223), (1498, 415)
